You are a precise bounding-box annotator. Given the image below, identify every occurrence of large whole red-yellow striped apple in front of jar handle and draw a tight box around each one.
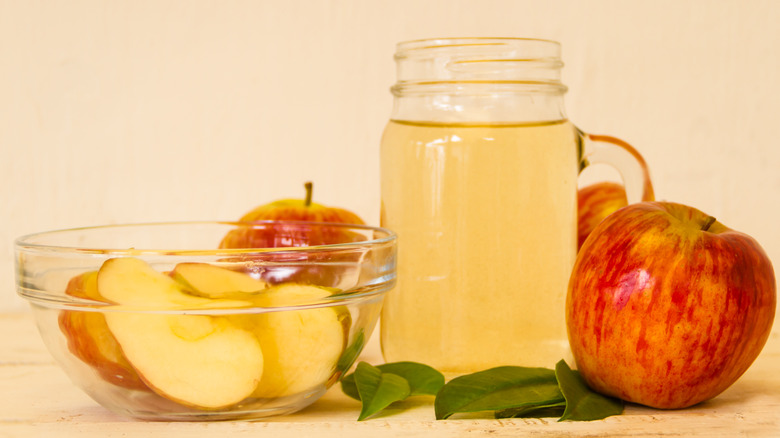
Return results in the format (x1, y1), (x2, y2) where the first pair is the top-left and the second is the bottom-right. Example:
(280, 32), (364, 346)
(566, 202), (777, 409)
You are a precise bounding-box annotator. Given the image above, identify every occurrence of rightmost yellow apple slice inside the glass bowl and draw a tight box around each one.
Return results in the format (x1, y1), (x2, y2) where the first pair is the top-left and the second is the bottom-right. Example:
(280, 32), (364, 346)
(244, 284), (349, 398)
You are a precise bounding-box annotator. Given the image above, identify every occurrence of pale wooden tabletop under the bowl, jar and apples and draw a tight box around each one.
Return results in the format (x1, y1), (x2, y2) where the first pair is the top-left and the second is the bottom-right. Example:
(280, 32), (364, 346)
(0, 313), (780, 438)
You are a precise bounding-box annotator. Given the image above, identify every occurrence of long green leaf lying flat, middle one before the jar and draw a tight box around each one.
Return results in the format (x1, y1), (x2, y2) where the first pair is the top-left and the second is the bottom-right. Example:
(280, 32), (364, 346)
(434, 366), (565, 420)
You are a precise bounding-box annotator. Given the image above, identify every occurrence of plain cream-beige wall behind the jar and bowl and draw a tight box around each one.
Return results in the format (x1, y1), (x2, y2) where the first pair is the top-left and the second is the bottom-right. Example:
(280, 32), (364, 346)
(0, 0), (780, 314)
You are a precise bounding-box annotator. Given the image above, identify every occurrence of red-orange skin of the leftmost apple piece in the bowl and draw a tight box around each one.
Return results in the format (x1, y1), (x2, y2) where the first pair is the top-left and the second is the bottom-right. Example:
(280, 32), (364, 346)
(58, 271), (149, 391)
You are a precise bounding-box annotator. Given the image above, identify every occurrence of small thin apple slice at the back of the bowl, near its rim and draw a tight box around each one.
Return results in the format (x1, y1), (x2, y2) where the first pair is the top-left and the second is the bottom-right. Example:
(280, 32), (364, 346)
(171, 263), (269, 298)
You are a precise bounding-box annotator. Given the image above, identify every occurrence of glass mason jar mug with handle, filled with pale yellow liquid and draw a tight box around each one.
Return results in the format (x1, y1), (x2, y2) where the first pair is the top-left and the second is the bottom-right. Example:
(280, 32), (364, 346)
(380, 38), (653, 373)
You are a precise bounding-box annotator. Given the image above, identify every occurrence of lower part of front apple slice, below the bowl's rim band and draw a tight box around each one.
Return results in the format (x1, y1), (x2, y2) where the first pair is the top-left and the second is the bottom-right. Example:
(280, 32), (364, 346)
(106, 313), (263, 409)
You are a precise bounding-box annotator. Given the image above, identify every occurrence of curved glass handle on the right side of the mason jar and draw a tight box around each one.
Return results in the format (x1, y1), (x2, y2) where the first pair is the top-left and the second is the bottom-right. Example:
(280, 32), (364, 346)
(580, 132), (655, 204)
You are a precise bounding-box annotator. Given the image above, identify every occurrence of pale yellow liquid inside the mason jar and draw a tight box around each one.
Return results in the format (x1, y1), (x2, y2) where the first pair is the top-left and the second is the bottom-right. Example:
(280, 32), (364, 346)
(380, 120), (578, 373)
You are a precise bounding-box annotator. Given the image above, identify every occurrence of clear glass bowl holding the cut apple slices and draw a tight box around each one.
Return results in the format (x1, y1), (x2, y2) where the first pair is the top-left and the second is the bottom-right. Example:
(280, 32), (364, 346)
(15, 221), (396, 421)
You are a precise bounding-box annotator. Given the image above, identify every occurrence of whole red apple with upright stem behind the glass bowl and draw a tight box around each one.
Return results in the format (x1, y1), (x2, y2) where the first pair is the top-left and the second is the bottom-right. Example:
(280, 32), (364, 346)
(219, 182), (366, 287)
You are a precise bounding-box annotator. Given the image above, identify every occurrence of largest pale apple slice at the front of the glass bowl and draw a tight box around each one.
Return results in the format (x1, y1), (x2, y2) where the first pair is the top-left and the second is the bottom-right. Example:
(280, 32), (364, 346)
(97, 258), (263, 409)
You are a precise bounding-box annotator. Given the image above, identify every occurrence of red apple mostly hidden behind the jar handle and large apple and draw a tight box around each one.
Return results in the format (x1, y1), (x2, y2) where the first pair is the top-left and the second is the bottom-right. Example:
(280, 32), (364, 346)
(577, 182), (628, 250)
